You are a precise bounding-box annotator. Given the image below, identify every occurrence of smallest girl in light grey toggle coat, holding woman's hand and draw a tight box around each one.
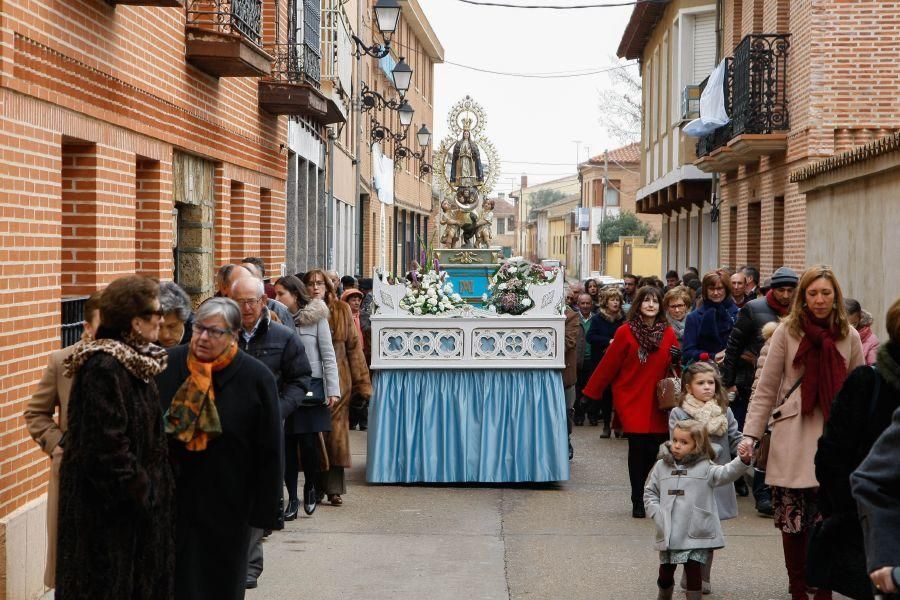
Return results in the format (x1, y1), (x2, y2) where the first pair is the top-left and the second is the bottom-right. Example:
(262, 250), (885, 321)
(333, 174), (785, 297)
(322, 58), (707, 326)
(644, 420), (751, 600)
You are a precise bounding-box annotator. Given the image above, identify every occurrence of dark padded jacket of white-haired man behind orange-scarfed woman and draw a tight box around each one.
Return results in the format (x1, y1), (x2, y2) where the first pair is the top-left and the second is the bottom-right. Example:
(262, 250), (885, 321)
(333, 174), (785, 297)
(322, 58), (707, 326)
(239, 312), (312, 419)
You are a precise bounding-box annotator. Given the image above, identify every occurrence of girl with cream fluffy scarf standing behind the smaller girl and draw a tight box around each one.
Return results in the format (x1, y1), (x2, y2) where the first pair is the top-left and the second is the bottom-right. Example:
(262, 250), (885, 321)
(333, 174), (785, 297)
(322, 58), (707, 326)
(669, 361), (741, 594)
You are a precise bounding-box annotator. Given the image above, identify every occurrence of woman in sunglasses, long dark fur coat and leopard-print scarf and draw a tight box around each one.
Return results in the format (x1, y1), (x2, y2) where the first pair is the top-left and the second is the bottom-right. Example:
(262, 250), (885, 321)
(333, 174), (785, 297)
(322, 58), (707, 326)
(56, 275), (174, 600)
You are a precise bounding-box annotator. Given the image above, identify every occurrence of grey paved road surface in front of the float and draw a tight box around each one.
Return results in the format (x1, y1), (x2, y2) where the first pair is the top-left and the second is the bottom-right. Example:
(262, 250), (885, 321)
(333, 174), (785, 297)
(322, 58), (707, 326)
(247, 426), (852, 600)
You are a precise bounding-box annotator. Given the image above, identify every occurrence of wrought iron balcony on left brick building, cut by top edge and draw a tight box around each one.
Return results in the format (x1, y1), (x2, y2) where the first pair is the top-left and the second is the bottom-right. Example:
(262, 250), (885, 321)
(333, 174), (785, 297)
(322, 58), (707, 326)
(186, 0), (273, 77)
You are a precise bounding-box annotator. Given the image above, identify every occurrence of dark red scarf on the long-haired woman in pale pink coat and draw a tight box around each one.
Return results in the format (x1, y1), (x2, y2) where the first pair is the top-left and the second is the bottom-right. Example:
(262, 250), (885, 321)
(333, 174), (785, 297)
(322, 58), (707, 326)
(793, 308), (847, 421)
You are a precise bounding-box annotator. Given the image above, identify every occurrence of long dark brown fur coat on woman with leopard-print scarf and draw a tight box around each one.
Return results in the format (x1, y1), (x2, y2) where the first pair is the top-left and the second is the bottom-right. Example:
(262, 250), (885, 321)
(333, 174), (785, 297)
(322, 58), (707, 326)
(56, 352), (175, 600)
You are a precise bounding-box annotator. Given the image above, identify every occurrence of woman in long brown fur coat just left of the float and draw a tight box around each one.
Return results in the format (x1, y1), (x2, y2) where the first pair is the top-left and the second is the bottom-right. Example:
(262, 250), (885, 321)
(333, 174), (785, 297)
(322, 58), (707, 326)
(303, 269), (372, 506)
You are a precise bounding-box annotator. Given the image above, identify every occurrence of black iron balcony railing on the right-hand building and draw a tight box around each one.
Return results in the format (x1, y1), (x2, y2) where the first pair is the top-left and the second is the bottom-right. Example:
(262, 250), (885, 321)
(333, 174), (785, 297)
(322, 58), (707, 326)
(697, 34), (790, 158)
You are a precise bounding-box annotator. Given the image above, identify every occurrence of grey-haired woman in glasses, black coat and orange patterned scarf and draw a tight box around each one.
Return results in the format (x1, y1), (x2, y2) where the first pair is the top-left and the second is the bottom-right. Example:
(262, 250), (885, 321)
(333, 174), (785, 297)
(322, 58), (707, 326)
(157, 298), (283, 600)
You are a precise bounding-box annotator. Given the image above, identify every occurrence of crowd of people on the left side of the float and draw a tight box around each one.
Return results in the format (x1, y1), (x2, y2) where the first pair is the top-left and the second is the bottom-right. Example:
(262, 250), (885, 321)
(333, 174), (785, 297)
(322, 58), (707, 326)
(24, 257), (372, 600)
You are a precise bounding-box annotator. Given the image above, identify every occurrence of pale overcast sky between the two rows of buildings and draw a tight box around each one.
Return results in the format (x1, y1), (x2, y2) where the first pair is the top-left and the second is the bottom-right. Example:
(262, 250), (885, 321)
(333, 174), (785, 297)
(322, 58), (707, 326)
(419, 0), (633, 196)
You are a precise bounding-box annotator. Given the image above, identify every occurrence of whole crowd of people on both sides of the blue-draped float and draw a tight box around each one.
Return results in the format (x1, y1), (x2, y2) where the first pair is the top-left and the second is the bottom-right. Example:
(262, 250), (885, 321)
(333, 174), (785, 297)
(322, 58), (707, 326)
(24, 257), (900, 600)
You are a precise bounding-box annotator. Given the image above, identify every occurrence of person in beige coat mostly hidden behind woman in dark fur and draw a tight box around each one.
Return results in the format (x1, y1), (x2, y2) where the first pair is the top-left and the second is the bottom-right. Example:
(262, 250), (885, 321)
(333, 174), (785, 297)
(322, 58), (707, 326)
(24, 292), (100, 588)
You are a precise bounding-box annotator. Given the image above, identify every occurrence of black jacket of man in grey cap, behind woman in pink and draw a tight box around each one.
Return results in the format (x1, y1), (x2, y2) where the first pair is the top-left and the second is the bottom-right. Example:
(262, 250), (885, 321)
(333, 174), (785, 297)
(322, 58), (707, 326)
(722, 297), (778, 387)
